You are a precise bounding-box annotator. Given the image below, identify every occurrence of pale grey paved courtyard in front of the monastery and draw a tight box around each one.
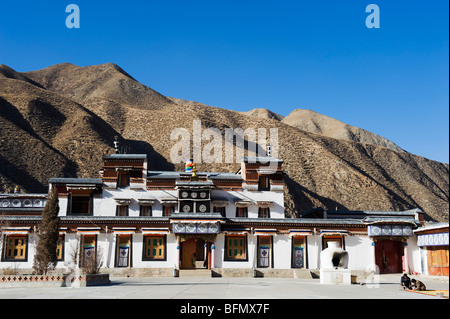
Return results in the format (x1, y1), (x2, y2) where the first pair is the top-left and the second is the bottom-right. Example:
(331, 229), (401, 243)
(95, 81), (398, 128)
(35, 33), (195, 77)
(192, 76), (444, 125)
(0, 274), (449, 300)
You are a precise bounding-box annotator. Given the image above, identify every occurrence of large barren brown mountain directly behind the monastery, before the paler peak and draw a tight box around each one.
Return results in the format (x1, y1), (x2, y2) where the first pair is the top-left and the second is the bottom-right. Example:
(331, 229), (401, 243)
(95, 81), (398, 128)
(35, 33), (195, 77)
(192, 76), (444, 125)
(0, 64), (449, 221)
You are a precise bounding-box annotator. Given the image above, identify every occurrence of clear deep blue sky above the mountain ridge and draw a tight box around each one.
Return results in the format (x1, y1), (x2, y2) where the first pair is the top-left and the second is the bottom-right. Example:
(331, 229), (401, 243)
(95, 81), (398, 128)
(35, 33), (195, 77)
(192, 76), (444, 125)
(0, 0), (449, 163)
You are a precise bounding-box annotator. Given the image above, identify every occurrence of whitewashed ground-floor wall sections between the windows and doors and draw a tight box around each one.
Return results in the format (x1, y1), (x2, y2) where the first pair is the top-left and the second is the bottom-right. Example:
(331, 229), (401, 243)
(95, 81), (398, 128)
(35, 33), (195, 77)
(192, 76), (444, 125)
(0, 233), (426, 274)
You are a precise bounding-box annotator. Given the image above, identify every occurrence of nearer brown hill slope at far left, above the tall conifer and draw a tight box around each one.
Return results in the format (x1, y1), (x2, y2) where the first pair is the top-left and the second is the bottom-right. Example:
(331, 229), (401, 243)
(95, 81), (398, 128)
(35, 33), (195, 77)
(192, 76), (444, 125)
(0, 70), (122, 192)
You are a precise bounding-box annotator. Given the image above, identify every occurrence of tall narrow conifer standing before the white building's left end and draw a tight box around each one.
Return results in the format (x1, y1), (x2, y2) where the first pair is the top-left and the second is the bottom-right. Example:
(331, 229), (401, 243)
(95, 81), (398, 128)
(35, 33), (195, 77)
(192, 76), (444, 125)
(33, 189), (60, 275)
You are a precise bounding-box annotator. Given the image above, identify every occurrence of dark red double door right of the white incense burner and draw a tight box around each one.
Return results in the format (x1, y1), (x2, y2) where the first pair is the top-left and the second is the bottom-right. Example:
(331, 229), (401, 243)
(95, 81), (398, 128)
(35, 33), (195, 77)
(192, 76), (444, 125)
(375, 239), (403, 274)
